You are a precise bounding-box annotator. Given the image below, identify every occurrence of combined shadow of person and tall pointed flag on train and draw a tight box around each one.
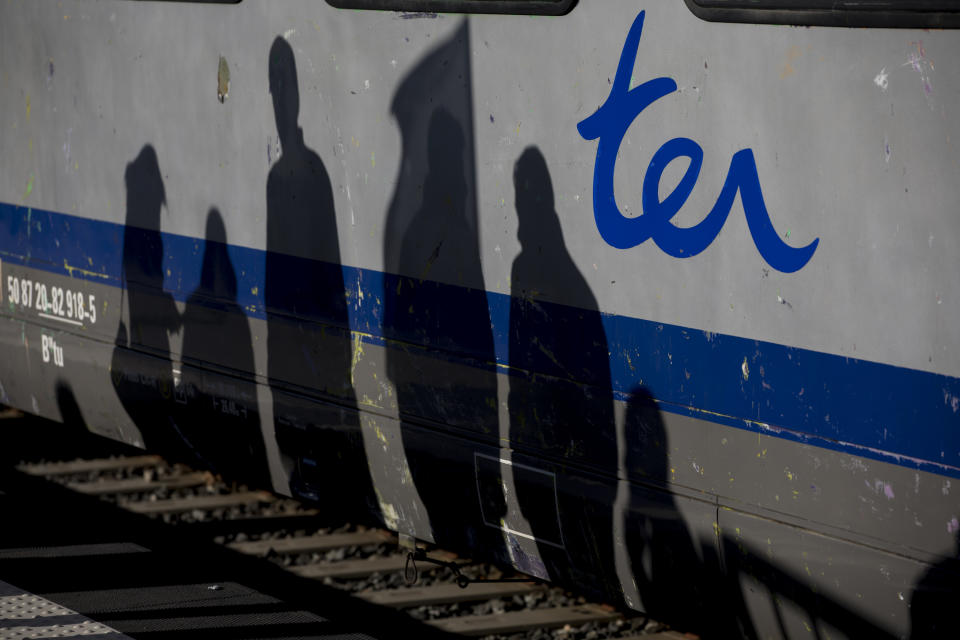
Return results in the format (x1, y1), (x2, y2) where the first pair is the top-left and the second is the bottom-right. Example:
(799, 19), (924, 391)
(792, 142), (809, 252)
(383, 20), (503, 559)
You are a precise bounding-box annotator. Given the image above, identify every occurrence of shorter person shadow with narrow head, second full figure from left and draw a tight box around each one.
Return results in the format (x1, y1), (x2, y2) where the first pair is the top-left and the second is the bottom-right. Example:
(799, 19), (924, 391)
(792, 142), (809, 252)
(174, 209), (270, 488)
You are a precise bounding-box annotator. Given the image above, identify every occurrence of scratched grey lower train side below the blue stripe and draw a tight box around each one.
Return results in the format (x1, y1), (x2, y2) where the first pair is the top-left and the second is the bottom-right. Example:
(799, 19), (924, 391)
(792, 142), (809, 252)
(0, 270), (956, 635)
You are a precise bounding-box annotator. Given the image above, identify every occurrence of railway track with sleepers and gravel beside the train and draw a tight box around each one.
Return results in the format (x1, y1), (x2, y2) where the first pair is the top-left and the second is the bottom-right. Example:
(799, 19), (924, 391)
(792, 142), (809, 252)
(9, 412), (691, 640)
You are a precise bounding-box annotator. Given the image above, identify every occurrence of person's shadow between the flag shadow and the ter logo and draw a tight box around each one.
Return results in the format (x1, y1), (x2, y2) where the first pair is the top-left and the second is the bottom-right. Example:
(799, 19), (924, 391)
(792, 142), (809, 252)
(509, 147), (617, 592)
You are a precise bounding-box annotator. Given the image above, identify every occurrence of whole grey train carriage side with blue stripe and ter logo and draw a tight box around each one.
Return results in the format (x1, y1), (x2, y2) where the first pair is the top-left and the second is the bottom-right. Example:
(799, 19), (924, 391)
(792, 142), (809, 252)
(0, 0), (960, 637)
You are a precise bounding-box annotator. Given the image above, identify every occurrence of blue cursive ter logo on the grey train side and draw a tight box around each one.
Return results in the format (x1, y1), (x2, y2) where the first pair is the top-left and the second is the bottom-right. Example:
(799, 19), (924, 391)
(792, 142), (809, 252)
(577, 11), (820, 273)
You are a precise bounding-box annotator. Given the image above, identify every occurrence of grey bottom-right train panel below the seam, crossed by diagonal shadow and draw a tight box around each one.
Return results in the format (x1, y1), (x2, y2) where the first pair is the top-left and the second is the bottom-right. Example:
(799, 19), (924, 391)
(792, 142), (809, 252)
(720, 511), (936, 638)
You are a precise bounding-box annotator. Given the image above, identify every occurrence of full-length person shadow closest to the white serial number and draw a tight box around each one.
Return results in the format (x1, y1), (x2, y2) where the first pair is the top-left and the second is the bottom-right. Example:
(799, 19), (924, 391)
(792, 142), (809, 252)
(110, 145), (190, 459)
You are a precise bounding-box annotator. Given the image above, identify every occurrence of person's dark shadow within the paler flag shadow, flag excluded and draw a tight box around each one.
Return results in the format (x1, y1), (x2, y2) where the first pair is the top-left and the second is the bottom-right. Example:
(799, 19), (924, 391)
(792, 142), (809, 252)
(384, 108), (497, 544)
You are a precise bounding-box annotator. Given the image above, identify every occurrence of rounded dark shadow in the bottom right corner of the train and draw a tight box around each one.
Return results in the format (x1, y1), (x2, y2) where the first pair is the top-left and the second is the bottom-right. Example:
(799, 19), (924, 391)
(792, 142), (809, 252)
(910, 520), (960, 639)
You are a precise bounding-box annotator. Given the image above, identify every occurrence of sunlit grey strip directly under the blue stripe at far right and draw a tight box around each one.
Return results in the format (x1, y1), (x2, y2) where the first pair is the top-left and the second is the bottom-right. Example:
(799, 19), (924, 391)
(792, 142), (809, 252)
(656, 412), (960, 560)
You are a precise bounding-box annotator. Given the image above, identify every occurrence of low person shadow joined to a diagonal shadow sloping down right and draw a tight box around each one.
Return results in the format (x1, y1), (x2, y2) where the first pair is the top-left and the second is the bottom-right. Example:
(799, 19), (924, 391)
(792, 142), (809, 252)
(625, 387), (908, 639)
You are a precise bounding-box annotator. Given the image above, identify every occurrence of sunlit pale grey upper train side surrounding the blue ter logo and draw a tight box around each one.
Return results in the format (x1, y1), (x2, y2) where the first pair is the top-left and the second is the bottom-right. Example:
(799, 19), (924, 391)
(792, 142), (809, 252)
(2, 2), (960, 375)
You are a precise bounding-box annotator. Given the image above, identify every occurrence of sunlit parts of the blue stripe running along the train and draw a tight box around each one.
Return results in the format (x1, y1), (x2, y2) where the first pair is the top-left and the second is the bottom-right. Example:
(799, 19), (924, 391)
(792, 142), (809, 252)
(0, 204), (960, 477)
